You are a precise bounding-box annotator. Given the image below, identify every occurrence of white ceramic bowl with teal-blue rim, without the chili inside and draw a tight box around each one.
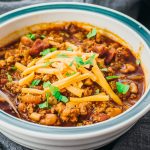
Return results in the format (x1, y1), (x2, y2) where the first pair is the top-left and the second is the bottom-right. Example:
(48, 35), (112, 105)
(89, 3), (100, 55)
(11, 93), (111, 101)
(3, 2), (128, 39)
(0, 3), (150, 150)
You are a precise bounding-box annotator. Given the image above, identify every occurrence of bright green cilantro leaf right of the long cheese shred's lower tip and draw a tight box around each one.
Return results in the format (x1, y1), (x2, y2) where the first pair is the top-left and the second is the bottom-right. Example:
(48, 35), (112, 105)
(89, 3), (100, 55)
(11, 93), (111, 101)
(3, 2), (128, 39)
(116, 82), (130, 94)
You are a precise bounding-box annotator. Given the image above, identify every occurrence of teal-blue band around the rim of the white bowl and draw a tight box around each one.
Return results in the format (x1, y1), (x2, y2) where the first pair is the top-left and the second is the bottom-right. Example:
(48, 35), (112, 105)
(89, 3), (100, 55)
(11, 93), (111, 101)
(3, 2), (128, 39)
(0, 3), (150, 135)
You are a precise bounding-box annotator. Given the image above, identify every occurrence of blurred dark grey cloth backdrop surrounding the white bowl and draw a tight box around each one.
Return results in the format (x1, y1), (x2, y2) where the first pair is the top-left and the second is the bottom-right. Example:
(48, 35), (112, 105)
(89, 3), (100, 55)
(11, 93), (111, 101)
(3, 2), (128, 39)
(0, 0), (150, 150)
